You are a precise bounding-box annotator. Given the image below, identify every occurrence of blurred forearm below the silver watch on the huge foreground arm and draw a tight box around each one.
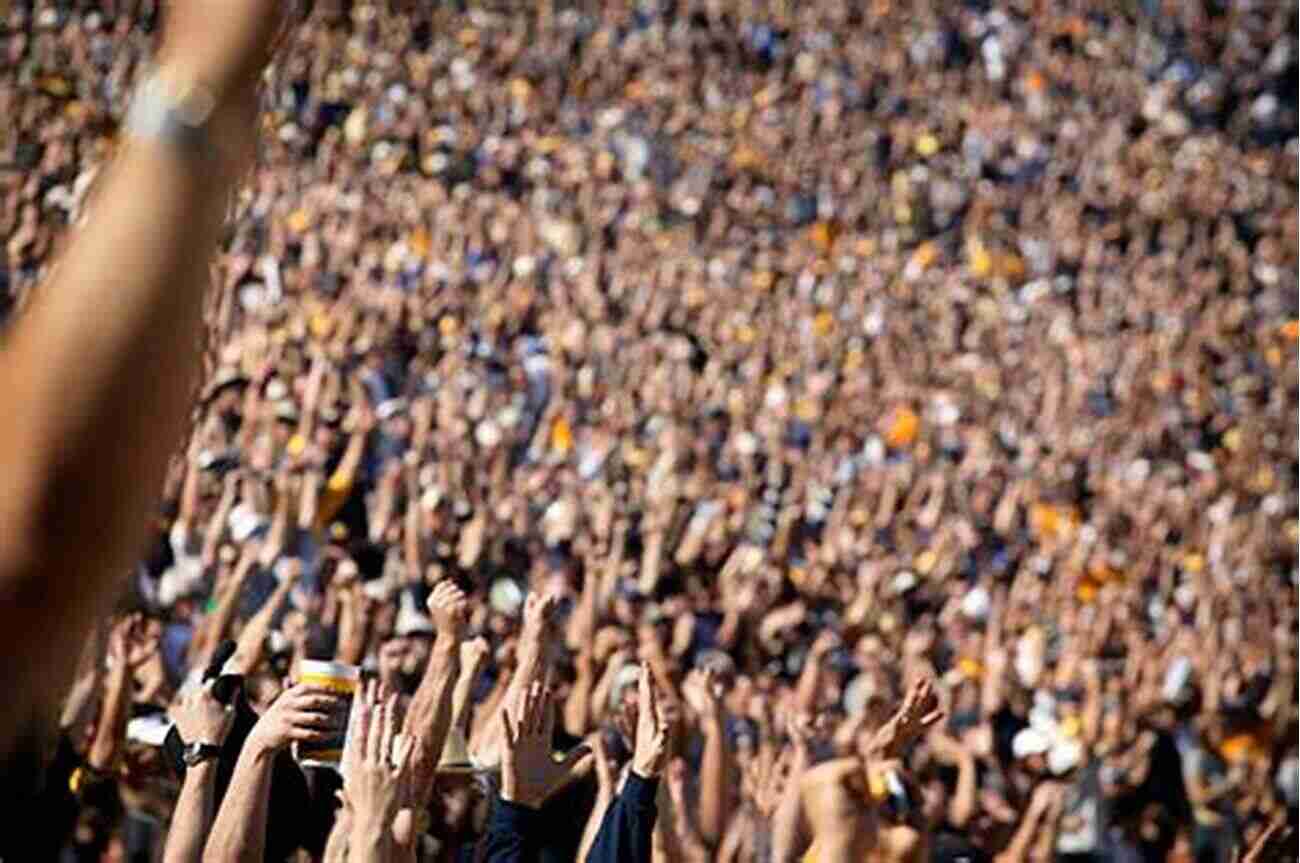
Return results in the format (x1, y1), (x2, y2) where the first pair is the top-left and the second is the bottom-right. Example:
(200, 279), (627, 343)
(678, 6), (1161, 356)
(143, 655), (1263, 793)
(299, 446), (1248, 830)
(0, 121), (233, 665)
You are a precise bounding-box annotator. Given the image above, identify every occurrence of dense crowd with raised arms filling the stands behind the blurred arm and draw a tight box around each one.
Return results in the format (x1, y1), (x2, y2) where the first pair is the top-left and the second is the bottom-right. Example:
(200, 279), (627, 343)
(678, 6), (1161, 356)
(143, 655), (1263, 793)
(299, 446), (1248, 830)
(0, 0), (1300, 863)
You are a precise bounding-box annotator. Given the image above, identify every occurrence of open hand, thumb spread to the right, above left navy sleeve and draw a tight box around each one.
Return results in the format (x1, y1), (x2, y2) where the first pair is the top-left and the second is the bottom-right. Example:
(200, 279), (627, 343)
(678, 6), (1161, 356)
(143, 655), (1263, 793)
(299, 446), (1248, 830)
(501, 682), (590, 808)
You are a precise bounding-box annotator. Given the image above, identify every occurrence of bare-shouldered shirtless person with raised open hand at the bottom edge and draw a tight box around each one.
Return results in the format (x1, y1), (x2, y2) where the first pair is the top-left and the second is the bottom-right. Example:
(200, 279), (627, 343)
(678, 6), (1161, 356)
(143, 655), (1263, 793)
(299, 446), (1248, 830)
(798, 678), (943, 863)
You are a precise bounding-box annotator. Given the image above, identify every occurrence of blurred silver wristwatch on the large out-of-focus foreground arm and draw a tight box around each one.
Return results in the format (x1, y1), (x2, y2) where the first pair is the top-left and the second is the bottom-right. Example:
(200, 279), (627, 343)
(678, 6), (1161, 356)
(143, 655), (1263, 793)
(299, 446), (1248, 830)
(126, 66), (217, 156)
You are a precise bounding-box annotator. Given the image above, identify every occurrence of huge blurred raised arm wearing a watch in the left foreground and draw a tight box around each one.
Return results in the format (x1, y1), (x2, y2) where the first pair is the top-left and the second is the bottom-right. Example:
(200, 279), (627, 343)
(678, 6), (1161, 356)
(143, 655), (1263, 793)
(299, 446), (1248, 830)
(0, 0), (293, 747)
